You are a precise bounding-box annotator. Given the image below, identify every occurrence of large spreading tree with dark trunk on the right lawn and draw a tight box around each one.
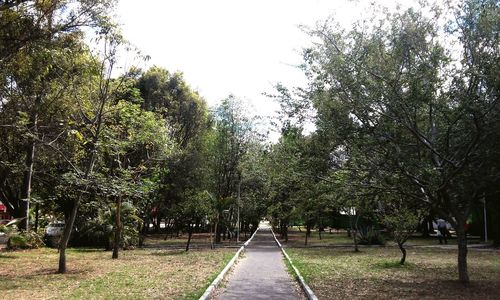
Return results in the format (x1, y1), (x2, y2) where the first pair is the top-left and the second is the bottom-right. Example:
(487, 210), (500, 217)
(305, 1), (498, 283)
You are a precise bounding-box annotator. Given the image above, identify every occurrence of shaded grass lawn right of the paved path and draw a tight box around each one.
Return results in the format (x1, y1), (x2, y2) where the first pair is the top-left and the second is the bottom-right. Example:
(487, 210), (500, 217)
(286, 247), (500, 299)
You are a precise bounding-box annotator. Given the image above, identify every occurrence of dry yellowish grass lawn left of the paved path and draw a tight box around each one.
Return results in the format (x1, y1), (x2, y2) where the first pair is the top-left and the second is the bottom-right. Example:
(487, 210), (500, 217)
(0, 248), (235, 299)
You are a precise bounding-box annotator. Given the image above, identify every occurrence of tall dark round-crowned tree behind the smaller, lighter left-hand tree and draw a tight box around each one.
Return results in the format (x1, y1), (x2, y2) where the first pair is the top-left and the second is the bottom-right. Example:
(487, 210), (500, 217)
(136, 67), (210, 238)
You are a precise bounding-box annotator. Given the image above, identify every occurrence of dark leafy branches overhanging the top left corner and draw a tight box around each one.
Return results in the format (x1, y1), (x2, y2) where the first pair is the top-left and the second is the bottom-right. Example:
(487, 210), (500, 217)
(0, 0), (114, 65)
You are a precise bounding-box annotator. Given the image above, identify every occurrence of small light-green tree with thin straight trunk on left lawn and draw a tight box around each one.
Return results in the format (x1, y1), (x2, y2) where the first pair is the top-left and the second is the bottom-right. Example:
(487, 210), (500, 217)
(96, 100), (171, 258)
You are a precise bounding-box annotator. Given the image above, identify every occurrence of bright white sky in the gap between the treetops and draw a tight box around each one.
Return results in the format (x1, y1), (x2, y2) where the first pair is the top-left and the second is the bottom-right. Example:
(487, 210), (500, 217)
(117, 0), (410, 133)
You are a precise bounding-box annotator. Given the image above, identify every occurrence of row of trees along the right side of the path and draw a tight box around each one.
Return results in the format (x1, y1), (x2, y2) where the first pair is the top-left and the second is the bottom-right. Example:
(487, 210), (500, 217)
(264, 0), (500, 283)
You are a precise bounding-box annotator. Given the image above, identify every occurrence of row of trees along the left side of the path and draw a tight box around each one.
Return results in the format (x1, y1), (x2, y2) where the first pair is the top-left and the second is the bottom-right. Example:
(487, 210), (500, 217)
(0, 0), (262, 273)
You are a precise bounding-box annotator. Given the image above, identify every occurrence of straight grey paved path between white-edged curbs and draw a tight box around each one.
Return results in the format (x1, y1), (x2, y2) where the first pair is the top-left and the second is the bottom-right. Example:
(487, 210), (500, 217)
(218, 224), (305, 300)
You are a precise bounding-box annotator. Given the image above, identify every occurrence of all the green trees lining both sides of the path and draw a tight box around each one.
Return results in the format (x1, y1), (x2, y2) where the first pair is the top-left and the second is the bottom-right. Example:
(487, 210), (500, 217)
(0, 0), (500, 282)
